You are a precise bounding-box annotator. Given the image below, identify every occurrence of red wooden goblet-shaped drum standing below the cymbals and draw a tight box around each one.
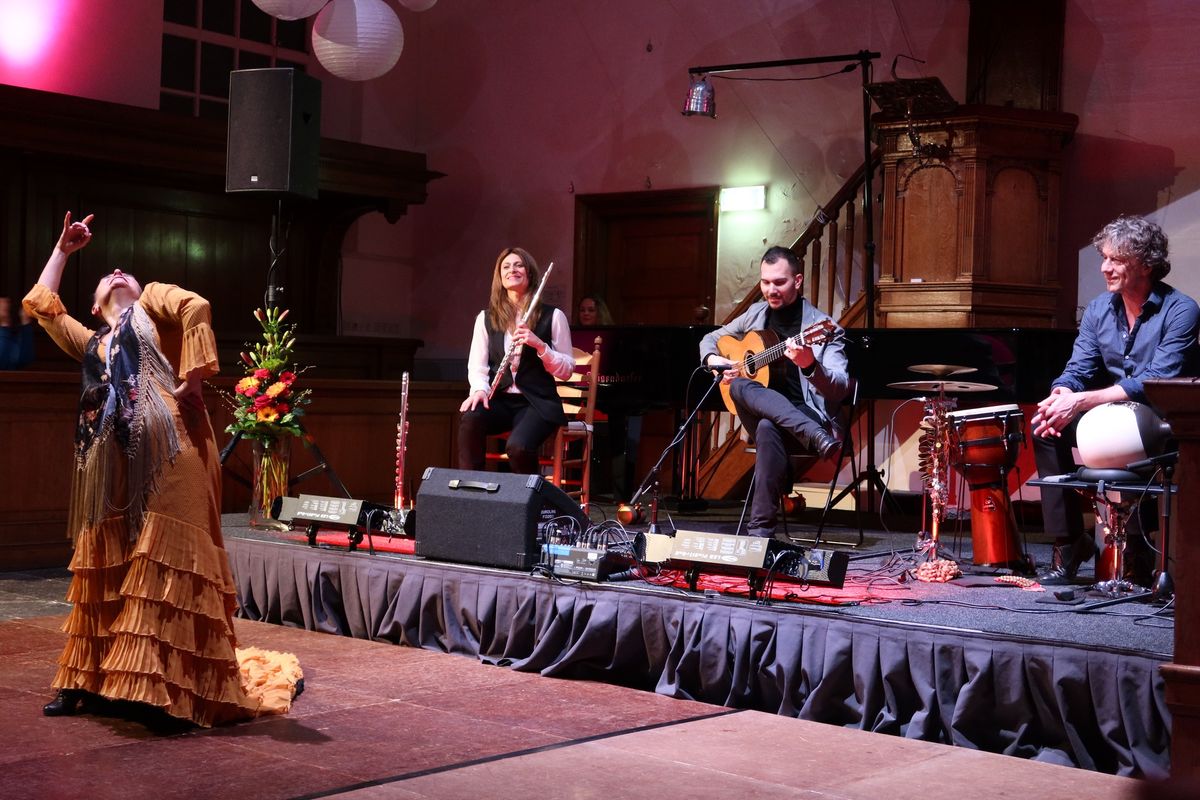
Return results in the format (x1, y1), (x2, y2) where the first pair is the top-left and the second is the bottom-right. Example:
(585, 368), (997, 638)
(946, 404), (1025, 566)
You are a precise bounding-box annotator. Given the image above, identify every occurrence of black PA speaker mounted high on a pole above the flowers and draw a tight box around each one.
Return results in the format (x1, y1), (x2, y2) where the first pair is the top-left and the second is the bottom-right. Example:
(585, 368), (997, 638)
(226, 68), (320, 198)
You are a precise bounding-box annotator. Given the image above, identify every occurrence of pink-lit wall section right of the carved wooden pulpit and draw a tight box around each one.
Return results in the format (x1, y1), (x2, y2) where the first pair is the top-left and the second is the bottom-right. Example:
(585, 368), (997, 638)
(1063, 0), (1200, 316)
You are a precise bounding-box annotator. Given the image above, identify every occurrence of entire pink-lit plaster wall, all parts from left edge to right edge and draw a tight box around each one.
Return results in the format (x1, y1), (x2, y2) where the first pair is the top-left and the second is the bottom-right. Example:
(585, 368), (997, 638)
(7, 0), (1200, 369)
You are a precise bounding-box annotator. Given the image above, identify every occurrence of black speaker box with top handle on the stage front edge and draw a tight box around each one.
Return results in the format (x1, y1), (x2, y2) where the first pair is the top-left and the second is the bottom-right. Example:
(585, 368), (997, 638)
(415, 467), (588, 570)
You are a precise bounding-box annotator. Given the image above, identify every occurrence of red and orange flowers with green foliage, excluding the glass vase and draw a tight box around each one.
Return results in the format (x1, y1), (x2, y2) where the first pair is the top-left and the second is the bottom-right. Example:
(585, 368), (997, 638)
(226, 308), (311, 443)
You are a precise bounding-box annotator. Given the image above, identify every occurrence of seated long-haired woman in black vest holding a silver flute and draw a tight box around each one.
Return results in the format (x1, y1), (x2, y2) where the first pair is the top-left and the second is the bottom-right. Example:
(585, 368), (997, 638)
(458, 247), (575, 474)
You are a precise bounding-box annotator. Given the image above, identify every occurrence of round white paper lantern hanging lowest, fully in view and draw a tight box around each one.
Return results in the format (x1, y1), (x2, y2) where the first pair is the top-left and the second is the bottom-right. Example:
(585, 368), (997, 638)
(312, 0), (404, 80)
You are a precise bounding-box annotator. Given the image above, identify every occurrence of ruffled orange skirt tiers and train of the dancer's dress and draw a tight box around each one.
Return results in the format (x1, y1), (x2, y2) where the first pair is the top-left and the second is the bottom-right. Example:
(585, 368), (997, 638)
(54, 512), (301, 727)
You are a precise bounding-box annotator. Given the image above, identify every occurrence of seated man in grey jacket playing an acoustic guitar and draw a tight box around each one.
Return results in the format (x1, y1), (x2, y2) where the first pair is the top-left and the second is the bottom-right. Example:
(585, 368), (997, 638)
(700, 246), (851, 537)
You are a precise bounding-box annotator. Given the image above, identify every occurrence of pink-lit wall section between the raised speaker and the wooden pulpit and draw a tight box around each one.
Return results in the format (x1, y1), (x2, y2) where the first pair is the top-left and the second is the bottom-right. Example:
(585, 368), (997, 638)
(347, 0), (967, 359)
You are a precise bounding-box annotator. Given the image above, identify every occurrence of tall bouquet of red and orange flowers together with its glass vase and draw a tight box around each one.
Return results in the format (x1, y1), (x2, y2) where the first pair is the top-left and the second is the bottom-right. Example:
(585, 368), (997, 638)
(226, 308), (311, 529)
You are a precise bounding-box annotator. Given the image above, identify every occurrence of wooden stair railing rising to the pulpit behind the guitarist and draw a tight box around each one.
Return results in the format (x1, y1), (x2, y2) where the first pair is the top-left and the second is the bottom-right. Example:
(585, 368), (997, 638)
(696, 151), (881, 498)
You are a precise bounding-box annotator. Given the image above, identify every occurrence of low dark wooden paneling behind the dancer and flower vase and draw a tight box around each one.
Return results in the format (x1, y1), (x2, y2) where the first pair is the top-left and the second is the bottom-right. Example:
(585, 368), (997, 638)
(0, 372), (463, 571)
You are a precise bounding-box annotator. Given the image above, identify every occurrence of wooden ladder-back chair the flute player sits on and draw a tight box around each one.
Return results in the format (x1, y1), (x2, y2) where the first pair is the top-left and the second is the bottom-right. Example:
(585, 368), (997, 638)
(487, 336), (600, 510)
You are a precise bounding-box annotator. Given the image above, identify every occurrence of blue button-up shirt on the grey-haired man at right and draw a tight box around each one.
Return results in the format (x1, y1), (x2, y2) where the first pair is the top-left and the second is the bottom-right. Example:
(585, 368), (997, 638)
(1051, 281), (1200, 403)
